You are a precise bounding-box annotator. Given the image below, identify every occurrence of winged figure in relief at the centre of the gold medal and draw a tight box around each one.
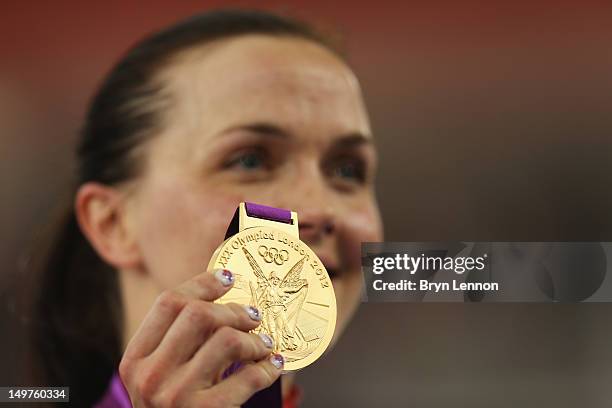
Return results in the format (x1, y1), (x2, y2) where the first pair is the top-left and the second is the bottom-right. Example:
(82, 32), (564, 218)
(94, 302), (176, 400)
(242, 247), (308, 351)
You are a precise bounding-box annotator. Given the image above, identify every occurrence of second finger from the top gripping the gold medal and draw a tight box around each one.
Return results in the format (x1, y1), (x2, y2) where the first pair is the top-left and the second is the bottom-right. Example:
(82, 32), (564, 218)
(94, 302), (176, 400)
(152, 300), (261, 365)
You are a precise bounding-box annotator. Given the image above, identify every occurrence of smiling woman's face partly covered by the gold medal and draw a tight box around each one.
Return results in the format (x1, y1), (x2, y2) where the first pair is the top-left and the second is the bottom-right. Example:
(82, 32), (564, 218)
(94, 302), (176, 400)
(124, 35), (382, 344)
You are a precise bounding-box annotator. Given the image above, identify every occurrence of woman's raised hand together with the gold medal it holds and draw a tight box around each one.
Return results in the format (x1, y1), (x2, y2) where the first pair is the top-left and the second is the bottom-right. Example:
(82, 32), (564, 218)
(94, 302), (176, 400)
(119, 203), (336, 407)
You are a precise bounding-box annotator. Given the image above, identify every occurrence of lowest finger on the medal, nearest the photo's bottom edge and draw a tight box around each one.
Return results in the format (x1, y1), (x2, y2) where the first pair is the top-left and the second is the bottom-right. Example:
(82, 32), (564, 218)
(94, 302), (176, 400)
(194, 354), (284, 406)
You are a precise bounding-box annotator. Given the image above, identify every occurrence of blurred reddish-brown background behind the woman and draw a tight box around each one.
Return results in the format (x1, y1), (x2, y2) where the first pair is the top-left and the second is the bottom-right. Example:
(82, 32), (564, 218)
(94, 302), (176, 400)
(0, 0), (612, 407)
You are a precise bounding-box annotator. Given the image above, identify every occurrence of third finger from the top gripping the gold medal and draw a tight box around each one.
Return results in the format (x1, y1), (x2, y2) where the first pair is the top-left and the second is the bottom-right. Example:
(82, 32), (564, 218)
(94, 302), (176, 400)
(187, 326), (274, 388)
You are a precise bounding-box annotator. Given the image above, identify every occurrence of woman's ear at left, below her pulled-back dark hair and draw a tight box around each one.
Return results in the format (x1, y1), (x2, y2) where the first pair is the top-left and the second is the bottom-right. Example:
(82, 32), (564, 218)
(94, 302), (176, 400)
(74, 182), (142, 269)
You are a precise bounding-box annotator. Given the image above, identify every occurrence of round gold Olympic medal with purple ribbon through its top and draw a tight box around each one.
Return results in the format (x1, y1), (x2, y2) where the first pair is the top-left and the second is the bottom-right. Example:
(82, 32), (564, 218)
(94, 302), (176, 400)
(208, 203), (336, 371)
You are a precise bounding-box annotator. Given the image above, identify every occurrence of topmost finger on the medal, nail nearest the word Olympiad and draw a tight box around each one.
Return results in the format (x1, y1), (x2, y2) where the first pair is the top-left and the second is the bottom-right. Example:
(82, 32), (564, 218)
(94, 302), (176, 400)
(124, 269), (234, 358)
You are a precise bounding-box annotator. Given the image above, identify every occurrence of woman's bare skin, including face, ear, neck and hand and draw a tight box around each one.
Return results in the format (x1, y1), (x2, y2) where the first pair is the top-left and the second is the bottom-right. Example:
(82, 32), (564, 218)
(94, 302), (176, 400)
(76, 35), (383, 406)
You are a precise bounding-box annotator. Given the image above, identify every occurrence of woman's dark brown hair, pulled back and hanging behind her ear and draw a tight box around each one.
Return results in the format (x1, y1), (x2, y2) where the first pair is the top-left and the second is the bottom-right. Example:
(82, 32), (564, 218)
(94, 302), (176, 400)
(29, 10), (341, 406)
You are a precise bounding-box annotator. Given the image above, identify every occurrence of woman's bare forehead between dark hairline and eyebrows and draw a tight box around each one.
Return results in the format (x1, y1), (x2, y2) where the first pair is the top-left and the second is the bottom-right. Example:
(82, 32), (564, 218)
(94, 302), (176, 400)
(163, 35), (369, 134)
